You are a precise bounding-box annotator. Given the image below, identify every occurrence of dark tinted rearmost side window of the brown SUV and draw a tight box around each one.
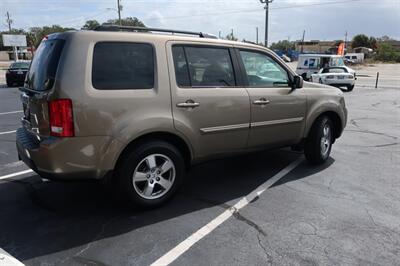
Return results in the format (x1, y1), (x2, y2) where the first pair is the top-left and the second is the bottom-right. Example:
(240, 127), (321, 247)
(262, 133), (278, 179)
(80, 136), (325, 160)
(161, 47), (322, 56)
(92, 42), (154, 90)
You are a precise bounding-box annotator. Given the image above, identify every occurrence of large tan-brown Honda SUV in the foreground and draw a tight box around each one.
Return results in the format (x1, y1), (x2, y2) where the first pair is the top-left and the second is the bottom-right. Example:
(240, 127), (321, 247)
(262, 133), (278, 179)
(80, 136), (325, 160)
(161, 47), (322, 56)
(16, 26), (347, 207)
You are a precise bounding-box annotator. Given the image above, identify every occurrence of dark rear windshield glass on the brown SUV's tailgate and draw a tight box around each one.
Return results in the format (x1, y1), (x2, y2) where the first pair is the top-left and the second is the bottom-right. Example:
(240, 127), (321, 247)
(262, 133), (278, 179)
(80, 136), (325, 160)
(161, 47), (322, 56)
(27, 40), (64, 91)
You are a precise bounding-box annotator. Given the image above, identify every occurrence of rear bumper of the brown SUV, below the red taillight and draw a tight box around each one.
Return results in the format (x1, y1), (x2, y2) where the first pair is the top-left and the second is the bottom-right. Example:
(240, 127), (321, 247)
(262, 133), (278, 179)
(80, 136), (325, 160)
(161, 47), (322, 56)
(16, 128), (118, 180)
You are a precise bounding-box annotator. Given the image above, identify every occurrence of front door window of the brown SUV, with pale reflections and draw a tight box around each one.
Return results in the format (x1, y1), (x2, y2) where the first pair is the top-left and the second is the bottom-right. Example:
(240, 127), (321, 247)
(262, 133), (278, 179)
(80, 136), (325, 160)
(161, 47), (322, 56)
(240, 51), (289, 87)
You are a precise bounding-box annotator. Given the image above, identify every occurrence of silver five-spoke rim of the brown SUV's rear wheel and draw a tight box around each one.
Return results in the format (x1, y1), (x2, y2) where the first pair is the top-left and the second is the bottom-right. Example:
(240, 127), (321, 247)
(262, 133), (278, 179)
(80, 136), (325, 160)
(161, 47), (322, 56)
(132, 154), (176, 200)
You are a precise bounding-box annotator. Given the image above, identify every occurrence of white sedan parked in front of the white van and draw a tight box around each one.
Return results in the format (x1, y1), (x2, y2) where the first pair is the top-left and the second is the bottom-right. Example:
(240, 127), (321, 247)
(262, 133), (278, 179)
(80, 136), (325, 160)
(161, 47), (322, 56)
(311, 67), (356, 91)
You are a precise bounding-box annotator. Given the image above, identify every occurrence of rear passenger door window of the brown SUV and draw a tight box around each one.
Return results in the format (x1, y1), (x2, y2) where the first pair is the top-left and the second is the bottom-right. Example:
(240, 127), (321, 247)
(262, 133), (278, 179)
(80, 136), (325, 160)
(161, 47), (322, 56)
(172, 46), (236, 87)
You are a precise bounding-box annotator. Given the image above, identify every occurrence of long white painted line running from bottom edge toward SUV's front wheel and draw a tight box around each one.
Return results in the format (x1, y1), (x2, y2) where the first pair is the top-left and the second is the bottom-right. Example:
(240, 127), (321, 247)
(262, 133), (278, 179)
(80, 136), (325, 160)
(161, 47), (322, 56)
(151, 157), (303, 266)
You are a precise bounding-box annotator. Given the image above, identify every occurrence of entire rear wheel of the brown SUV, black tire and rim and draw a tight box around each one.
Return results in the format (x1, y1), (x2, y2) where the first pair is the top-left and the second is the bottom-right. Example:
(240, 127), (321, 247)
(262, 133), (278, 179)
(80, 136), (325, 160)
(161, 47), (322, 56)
(116, 140), (185, 209)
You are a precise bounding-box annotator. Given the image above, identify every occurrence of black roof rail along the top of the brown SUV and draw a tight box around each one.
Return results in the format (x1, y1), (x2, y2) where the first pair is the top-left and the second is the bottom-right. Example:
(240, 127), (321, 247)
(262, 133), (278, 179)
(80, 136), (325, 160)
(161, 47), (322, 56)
(94, 24), (218, 39)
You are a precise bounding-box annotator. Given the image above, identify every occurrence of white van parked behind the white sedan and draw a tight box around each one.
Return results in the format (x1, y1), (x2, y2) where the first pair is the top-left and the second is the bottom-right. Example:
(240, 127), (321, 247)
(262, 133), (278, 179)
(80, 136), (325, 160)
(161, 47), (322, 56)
(296, 54), (355, 80)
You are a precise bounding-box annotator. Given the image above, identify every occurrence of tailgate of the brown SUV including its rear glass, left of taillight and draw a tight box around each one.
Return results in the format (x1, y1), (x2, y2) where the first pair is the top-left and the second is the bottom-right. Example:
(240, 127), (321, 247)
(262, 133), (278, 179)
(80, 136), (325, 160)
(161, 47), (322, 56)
(21, 39), (65, 135)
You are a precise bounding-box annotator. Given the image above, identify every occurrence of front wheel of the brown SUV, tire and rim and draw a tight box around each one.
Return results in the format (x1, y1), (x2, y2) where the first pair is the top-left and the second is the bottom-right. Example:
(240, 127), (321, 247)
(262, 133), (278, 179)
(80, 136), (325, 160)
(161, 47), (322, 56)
(304, 116), (334, 164)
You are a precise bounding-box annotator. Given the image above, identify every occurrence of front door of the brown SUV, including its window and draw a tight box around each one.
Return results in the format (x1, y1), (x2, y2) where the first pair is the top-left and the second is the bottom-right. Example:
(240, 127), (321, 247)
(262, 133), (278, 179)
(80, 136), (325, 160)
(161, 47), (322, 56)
(239, 49), (306, 147)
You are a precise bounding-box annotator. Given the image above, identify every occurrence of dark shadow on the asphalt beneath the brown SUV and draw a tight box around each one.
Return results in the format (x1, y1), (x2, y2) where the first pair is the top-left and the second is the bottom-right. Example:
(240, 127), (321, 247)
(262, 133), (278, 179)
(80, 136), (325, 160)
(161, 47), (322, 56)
(0, 149), (333, 260)
